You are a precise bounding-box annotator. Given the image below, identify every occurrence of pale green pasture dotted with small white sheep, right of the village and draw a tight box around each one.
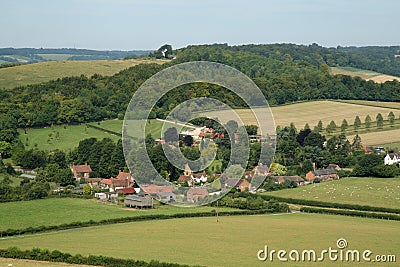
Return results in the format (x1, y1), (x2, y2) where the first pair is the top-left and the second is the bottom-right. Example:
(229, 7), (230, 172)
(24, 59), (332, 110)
(263, 177), (400, 211)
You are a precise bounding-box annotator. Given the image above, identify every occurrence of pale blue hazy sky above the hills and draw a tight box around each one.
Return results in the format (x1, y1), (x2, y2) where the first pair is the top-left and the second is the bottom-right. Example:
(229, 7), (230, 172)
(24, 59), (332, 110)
(0, 0), (400, 50)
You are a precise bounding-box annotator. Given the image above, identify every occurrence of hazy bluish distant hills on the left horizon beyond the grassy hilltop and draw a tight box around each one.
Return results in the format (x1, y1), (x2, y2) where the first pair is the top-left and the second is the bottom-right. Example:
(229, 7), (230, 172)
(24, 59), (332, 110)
(0, 48), (152, 64)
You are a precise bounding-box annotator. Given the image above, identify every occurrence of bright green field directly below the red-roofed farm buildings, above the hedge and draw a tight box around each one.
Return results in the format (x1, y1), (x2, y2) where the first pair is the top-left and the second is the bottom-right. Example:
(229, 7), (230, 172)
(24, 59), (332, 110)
(0, 198), (236, 231)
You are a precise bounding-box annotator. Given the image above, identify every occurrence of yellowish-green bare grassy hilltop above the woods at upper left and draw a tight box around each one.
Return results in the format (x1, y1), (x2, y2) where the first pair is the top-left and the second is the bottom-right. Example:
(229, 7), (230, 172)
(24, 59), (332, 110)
(0, 59), (165, 89)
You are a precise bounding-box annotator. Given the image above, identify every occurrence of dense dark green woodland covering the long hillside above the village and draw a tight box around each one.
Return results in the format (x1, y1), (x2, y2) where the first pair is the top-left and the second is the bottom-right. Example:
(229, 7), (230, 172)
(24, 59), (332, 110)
(0, 45), (400, 133)
